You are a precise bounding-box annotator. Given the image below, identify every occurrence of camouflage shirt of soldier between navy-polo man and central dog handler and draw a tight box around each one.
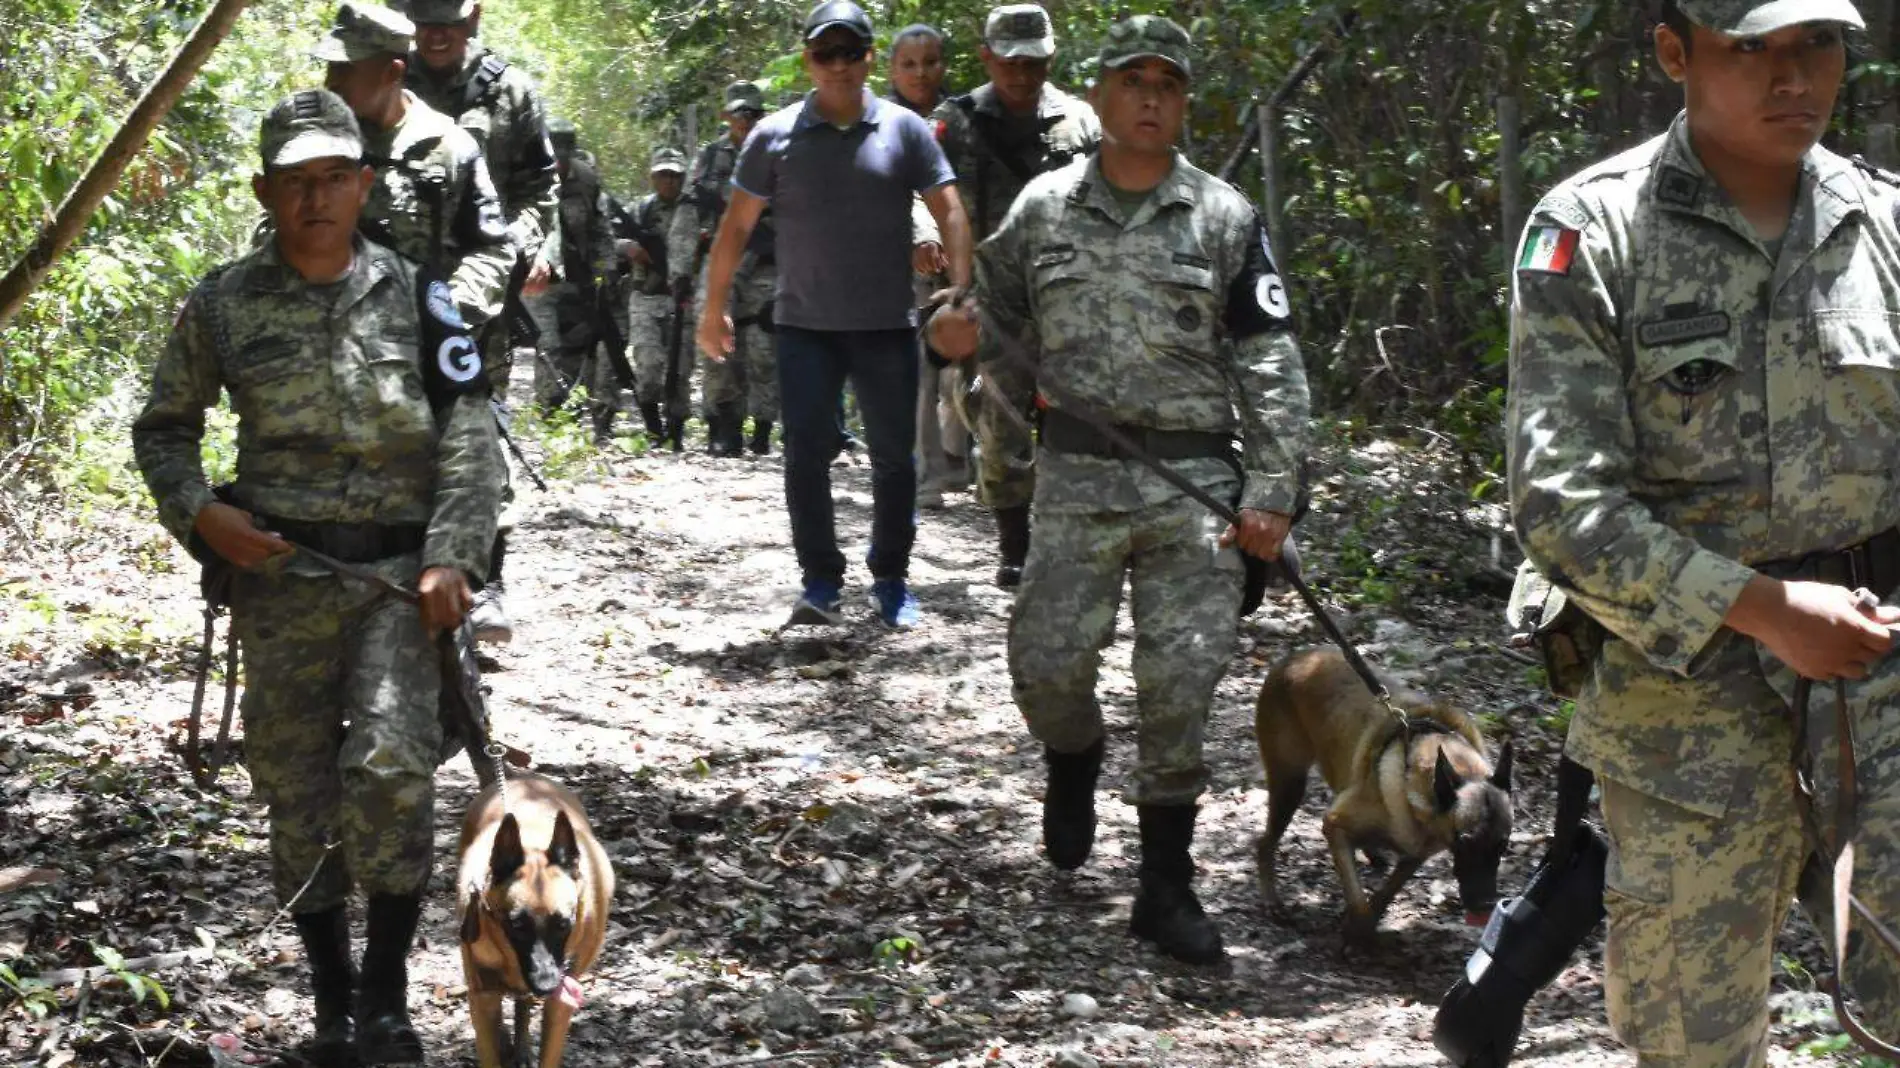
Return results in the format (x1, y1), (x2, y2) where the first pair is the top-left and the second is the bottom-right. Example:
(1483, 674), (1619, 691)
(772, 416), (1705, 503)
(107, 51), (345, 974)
(931, 84), (1102, 241)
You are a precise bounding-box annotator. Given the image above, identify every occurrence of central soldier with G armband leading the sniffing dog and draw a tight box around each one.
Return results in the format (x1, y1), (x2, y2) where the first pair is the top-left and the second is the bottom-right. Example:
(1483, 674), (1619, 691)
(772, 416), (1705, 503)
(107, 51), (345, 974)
(931, 15), (1307, 963)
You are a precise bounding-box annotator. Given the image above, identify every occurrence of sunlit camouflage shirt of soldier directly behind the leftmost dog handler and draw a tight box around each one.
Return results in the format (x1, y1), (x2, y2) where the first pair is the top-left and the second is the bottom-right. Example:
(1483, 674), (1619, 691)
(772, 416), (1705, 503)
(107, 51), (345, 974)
(357, 91), (515, 325)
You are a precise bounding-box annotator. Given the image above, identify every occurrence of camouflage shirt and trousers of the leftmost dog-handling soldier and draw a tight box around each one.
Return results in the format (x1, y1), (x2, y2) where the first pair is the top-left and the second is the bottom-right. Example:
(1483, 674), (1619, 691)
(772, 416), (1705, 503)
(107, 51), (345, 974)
(133, 230), (502, 896)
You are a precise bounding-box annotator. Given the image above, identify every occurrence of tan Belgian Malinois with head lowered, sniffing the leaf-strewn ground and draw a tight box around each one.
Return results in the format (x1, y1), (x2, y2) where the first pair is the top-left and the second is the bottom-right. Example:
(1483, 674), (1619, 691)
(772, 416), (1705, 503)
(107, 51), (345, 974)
(1254, 648), (1511, 941)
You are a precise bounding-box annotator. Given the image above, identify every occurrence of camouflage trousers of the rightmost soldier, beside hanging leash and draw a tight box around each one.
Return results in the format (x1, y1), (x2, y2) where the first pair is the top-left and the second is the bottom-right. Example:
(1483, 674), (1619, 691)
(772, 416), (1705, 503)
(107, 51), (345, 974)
(1602, 684), (1900, 1068)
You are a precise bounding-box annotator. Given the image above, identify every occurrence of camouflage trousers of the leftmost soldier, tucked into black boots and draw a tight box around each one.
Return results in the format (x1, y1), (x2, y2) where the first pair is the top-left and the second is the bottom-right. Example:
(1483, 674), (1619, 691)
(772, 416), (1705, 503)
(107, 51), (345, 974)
(232, 557), (443, 912)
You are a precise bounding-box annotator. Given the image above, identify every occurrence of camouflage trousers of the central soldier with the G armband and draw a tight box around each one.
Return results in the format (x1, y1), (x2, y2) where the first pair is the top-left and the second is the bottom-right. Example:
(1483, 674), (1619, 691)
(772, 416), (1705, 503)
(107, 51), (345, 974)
(1009, 483), (1243, 804)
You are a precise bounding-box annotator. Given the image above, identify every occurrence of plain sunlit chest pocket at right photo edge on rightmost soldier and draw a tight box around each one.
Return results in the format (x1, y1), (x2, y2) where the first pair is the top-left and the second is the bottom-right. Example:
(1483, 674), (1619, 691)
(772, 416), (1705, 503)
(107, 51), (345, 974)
(1815, 308), (1900, 475)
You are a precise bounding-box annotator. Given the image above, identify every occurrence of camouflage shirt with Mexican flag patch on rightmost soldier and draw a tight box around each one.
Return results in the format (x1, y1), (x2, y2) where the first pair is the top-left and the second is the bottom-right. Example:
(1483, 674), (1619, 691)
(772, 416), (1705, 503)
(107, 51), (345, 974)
(1507, 118), (1900, 813)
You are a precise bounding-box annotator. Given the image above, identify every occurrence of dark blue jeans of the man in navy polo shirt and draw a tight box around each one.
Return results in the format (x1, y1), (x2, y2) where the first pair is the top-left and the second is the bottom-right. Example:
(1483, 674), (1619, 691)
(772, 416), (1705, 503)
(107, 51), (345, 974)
(777, 323), (918, 585)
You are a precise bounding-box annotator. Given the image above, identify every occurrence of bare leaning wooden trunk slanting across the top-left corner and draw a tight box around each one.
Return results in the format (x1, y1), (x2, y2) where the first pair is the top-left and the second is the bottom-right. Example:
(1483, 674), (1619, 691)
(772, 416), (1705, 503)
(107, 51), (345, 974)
(0, 0), (251, 327)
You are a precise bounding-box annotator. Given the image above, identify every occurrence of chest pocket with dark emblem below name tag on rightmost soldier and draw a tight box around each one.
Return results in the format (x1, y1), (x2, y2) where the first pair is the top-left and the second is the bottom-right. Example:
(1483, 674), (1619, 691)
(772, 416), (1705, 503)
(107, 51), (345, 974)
(1630, 336), (1767, 483)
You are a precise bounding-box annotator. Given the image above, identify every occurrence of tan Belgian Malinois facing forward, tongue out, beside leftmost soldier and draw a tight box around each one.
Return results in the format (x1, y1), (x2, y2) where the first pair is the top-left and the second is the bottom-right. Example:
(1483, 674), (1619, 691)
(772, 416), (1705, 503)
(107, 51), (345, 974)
(456, 773), (614, 1068)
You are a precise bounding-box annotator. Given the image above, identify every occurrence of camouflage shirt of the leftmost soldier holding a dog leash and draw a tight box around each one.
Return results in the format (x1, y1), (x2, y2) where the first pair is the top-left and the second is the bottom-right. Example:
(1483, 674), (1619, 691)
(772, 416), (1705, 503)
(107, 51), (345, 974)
(131, 238), (502, 578)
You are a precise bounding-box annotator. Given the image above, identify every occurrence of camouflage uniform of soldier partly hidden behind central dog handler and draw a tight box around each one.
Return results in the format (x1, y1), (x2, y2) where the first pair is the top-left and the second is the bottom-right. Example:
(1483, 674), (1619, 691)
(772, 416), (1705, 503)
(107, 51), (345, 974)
(931, 76), (1102, 509)
